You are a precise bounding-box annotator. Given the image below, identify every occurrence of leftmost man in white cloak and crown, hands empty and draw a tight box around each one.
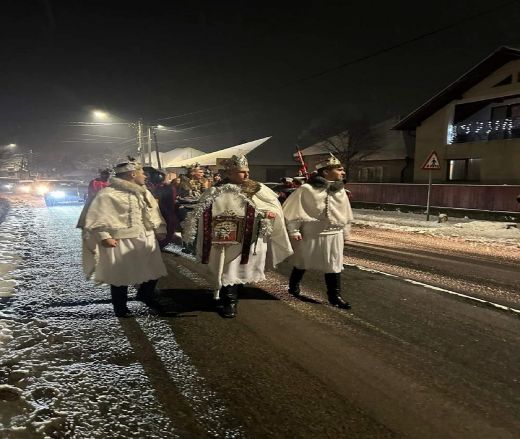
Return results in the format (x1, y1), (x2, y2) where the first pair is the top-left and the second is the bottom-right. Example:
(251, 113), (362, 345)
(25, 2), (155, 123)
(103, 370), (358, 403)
(78, 160), (166, 317)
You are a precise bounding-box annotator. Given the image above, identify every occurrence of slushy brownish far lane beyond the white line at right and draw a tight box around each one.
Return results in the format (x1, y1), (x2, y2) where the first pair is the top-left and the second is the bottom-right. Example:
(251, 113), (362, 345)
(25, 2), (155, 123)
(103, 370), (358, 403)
(345, 227), (520, 310)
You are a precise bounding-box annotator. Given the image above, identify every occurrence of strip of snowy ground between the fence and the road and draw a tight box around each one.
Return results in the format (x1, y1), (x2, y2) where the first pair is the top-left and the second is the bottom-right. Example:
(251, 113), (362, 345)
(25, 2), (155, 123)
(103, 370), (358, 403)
(354, 209), (520, 245)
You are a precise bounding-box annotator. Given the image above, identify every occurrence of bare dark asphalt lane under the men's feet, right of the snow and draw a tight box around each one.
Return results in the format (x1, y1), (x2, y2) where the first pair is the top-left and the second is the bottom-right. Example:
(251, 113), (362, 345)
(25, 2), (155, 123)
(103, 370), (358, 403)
(159, 249), (520, 438)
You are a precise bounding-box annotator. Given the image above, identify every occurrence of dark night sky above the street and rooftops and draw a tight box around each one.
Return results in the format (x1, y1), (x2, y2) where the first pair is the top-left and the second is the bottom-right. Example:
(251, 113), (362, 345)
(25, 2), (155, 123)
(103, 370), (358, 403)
(0, 0), (520, 165)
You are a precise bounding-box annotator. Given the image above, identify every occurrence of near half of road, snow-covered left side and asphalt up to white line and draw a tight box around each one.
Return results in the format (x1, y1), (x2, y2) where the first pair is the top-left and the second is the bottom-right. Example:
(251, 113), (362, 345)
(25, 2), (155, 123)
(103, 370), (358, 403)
(0, 201), (520, 438)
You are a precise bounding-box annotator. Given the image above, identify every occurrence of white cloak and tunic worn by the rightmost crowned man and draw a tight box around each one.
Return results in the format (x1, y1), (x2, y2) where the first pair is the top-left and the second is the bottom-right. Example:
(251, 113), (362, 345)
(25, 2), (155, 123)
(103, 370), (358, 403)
(283, 177), (353, 273)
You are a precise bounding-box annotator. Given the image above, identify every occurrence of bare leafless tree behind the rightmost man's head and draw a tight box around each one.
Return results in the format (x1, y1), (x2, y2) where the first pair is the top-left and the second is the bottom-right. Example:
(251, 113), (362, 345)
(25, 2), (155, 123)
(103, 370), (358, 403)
(298, 113), (380, 178)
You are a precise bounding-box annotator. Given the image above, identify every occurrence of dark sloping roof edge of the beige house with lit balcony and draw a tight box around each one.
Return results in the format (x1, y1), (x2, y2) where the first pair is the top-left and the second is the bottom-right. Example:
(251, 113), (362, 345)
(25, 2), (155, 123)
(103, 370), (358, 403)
(393, 46), (520, 130)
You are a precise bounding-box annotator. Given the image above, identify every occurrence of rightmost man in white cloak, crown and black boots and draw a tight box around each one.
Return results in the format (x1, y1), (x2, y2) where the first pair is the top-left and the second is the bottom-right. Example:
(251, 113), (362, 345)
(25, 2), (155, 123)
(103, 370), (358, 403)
(283, 154), (353, 309)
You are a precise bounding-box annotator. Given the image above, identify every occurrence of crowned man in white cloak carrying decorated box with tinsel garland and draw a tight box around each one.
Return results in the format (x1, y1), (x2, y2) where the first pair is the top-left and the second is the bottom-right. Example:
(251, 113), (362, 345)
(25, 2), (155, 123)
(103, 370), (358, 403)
(183, 156), (292, 318)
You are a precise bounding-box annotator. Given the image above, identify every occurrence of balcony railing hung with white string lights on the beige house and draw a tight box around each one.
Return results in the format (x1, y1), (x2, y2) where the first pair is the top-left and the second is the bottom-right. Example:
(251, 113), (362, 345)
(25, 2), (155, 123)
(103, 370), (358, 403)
(448, 118), (520, 143)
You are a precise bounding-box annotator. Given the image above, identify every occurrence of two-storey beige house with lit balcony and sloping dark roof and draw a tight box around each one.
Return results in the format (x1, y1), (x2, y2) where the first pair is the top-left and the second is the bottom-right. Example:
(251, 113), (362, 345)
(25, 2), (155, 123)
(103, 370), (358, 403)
(394, 47), (520, 185)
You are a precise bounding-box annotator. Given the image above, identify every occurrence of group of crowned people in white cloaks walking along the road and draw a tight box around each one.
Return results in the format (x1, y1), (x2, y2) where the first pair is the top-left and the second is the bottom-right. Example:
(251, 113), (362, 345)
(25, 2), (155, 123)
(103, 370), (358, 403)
(78, 155), (352, 318)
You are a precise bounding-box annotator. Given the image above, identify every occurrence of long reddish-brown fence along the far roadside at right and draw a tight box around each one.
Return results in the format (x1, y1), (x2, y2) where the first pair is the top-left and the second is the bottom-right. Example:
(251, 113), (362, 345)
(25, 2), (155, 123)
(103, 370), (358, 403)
(346, 183), (520, 212)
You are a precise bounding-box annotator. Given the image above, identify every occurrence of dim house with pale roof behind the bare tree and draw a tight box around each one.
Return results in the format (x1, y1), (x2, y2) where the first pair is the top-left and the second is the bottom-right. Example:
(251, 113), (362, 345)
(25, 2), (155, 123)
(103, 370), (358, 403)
(301, 117), (414, 183)
